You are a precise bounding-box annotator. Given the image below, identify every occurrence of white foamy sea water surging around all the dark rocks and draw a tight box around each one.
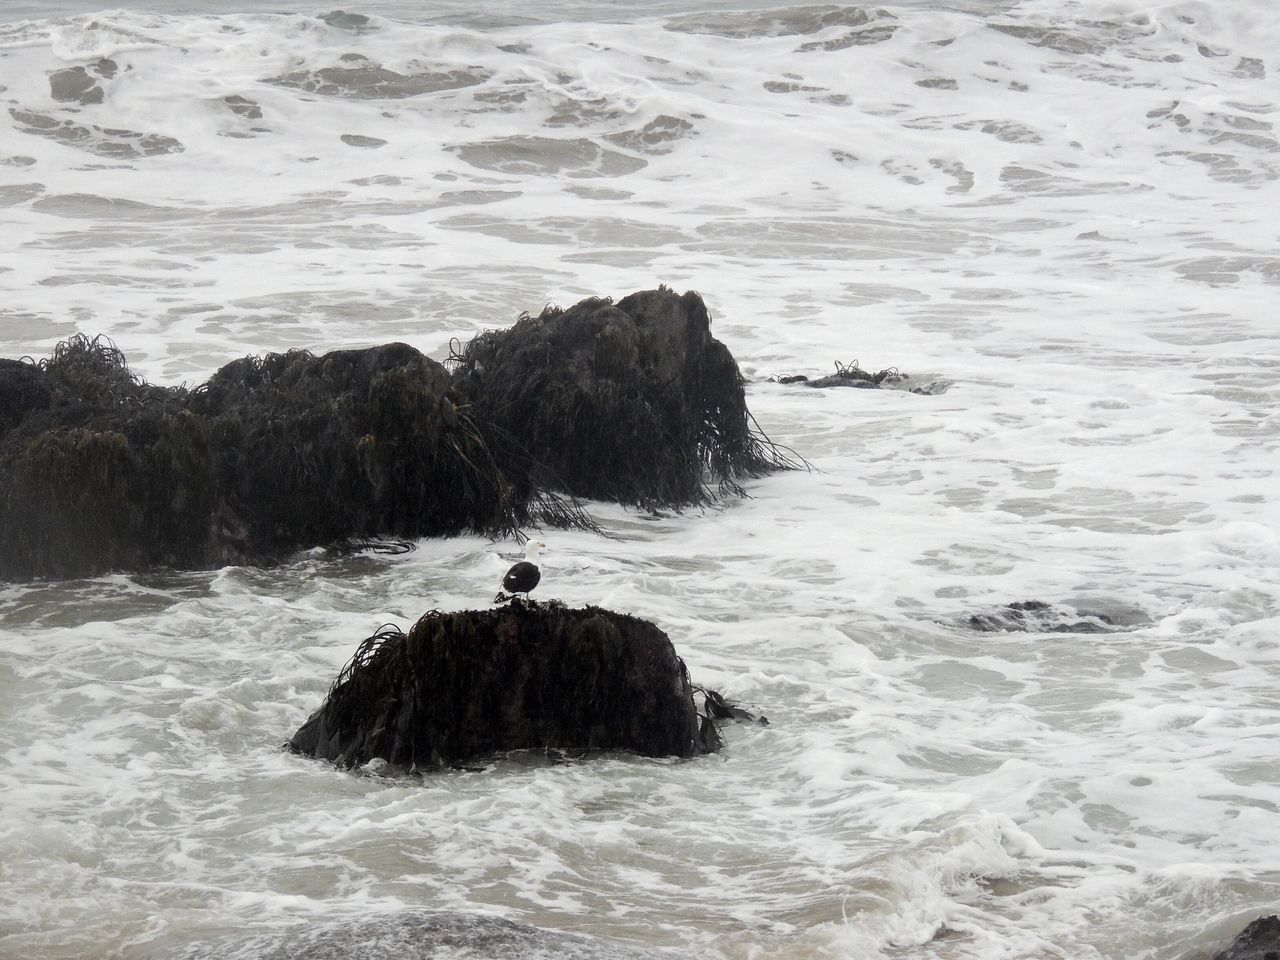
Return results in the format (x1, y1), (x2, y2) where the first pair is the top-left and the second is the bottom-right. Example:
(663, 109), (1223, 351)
(0, 0), (1280, 960)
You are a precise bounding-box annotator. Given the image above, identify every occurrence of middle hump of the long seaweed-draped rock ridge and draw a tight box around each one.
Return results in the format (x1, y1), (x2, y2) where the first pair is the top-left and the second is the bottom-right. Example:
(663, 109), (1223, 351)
(192, 343), (588, 556)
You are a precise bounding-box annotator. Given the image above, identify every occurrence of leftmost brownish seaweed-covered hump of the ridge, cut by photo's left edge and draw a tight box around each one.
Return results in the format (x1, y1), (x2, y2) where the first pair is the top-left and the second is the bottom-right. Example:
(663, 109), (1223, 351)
(0, 337), (214, 577)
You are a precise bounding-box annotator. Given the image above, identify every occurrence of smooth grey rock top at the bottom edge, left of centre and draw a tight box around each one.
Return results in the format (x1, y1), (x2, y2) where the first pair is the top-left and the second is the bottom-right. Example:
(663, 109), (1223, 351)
(151, 909), (672, 960)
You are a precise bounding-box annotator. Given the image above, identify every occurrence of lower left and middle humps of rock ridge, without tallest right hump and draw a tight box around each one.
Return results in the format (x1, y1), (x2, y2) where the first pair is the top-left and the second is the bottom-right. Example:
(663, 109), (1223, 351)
(0, 337), (591, 579)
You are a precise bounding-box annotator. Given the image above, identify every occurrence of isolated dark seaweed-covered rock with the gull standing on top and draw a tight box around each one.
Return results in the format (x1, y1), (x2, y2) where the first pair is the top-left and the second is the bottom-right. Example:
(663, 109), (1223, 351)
(288, 600), (719, 769)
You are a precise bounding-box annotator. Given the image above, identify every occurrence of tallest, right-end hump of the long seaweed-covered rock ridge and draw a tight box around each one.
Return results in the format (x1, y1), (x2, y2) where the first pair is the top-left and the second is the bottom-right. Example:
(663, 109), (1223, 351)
(453, 287), (791, 509)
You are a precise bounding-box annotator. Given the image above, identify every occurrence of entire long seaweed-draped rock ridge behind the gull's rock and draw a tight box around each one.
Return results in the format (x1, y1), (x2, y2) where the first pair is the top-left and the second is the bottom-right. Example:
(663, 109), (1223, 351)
(0, 288), (788, 579)
